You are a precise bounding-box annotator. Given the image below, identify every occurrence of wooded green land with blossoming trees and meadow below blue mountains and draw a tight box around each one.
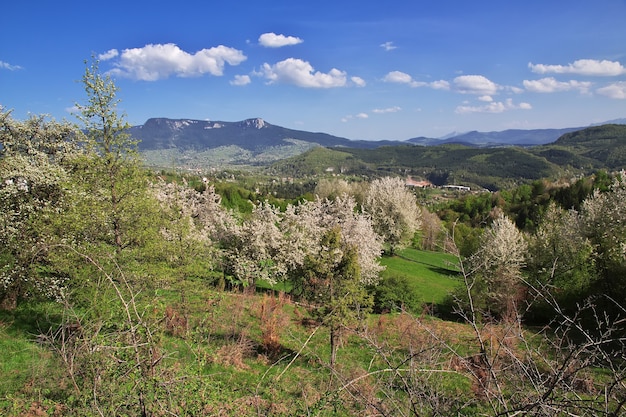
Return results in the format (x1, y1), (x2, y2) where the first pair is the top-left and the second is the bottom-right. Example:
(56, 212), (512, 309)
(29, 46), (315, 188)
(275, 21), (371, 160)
(0, 61), (626, 417)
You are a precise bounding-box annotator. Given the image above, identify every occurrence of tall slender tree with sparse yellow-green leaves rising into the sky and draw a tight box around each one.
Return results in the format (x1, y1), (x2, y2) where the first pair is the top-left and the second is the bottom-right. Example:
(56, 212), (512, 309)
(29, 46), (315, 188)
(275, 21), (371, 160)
(76, 59), (149, 253)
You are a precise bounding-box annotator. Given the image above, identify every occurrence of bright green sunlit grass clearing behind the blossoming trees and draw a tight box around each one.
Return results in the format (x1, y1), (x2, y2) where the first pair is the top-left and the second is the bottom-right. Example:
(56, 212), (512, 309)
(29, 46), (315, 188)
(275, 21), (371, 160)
(381, 248), (459, 304)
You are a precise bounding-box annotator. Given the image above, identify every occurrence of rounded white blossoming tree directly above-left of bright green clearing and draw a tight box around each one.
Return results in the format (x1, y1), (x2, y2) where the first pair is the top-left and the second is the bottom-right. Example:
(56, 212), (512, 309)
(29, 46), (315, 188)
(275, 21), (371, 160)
(363, 177), (421, 254)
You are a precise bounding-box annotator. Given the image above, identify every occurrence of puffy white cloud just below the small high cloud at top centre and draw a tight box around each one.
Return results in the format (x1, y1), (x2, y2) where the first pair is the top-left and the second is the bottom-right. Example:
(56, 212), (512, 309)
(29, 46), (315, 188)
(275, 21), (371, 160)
(261, 58), (347, 88)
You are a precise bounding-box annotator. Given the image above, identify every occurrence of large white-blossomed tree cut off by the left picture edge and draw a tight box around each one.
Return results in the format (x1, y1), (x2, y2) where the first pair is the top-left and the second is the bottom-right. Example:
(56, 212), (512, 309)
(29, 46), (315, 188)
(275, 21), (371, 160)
(0, 107), (78, 309)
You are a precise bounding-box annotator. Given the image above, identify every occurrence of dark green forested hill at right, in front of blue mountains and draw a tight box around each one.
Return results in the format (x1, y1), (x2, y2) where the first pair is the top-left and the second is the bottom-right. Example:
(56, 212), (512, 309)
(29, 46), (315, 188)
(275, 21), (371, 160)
(272, 125), (626, 190)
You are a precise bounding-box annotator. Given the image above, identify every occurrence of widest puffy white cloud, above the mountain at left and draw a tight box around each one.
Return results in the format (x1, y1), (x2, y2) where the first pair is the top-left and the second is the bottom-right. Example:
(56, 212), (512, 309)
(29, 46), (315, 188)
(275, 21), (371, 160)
(110, 43), (246, 81)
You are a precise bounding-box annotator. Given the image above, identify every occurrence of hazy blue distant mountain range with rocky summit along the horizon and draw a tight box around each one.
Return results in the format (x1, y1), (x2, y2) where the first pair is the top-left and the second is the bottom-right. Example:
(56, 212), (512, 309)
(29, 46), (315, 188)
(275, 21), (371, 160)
(129, 118), (626, 168)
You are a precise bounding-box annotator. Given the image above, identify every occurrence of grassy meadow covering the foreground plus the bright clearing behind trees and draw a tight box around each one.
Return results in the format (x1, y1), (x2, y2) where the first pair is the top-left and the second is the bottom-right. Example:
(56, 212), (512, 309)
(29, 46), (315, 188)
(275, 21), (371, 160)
(0, 248), (616, 416)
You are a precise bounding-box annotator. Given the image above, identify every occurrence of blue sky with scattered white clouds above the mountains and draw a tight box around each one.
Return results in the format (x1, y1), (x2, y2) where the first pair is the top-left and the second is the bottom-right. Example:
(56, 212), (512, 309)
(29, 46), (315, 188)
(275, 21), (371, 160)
(0, 0), (626, 140)
